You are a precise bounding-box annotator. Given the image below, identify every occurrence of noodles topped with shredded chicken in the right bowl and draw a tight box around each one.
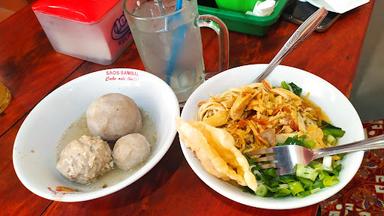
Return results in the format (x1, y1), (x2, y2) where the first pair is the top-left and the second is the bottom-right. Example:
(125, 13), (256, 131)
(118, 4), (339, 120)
(198, 81), (328, 154)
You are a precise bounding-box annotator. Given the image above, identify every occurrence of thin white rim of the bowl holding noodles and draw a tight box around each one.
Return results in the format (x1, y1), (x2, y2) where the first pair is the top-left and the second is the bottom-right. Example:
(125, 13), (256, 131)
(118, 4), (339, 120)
(179, 64), (365, 210)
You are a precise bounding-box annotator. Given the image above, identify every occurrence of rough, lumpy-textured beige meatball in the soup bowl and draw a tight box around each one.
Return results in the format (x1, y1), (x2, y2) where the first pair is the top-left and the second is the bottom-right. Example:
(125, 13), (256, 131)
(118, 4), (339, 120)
(56, 135), (113, 184)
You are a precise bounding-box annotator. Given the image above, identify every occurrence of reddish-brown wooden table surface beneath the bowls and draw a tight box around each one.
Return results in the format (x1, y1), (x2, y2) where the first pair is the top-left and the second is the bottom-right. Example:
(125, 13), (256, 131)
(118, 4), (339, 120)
(0, 1), (374, 216)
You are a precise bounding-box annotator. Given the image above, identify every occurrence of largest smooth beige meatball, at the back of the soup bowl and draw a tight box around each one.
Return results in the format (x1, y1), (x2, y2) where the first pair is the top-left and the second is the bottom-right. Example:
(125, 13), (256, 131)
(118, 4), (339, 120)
(86, 93), (142, 141)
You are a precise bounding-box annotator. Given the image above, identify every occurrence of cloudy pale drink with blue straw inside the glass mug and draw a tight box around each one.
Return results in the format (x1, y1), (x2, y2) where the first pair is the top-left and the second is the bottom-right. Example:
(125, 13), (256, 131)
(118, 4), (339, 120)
(130, 1), (204, 102)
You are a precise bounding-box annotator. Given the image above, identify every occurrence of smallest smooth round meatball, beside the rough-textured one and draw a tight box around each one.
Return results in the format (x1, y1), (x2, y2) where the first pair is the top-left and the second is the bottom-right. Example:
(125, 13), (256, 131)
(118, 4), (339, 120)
(112, 133), (151, 170)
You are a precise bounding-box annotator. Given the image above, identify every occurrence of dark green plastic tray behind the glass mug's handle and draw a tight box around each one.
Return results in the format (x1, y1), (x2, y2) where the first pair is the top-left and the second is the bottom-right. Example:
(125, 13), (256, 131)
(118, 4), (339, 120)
(199, 0), (288, 36)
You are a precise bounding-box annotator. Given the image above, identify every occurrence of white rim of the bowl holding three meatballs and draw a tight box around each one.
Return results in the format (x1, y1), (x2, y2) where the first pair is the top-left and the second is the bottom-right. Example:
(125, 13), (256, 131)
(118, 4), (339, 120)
(12, 68), (180, 202)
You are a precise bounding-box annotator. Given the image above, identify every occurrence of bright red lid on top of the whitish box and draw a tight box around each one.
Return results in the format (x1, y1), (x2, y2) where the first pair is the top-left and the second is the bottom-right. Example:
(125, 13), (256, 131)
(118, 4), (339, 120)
(32, 0), (120, 23)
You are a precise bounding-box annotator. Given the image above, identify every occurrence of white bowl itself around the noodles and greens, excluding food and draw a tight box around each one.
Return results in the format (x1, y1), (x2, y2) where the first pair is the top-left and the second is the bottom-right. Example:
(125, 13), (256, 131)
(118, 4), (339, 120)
(180, 64), (365, 209)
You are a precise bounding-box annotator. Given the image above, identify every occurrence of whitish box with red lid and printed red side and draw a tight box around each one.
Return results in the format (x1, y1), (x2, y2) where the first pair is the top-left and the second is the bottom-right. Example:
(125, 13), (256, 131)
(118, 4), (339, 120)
(32, 0), (132, 65)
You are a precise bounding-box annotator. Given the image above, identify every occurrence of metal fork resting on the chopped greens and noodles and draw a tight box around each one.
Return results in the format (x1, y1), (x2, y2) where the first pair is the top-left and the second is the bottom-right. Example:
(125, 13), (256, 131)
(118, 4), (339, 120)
(247, 135), (384, 175)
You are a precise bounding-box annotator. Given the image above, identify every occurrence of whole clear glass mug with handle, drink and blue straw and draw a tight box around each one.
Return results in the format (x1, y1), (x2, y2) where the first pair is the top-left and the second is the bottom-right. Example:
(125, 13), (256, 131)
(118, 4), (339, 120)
(124, 0), (229, 103)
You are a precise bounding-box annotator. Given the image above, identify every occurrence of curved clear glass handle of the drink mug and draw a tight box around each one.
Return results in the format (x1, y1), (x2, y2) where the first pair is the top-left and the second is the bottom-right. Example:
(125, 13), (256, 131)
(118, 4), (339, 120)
(197, 15), (229, 72)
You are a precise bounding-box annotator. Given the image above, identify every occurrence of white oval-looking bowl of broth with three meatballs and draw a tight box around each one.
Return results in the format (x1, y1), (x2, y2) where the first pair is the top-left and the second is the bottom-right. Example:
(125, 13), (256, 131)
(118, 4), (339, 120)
(13, 68), (180, 202)
